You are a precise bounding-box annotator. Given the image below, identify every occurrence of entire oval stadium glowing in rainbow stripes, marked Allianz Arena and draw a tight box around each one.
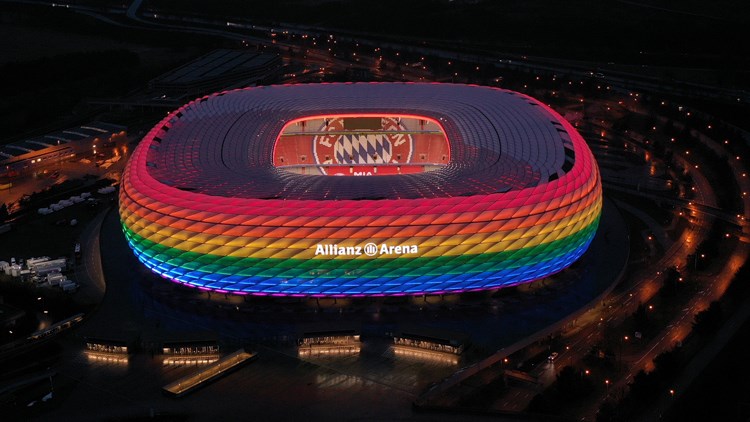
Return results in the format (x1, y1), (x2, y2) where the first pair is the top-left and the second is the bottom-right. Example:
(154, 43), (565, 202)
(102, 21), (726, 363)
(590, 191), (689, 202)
(120, 83), (602, 296)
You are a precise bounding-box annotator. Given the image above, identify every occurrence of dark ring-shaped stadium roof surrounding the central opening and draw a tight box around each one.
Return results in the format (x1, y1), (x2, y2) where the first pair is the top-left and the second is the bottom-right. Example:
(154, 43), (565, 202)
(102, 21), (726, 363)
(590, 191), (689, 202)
(147, 83), (575, 199)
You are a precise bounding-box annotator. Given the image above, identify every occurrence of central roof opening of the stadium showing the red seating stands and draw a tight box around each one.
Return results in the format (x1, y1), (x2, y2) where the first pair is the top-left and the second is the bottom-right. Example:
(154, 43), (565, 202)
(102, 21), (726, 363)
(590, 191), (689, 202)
(273, 114), (450, 176)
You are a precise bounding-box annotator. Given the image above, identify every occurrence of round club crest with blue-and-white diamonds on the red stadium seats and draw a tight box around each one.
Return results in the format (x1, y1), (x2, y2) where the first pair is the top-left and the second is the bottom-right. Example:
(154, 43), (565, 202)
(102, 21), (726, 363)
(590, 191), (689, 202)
(313, 117), (414, 176)
